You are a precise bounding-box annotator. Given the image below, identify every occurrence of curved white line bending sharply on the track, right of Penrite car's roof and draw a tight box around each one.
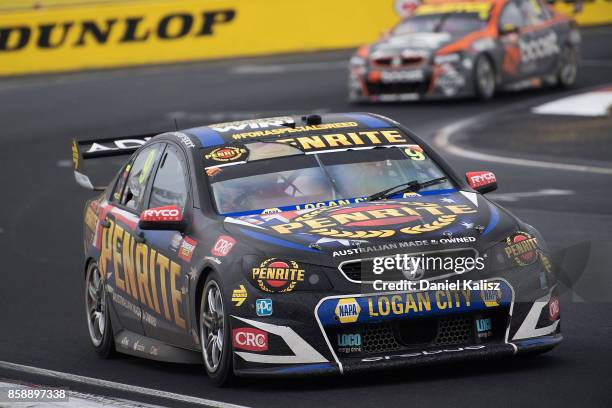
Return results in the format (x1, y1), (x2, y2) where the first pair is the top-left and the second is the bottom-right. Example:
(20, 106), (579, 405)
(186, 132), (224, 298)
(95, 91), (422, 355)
(433, 113), (612, 175)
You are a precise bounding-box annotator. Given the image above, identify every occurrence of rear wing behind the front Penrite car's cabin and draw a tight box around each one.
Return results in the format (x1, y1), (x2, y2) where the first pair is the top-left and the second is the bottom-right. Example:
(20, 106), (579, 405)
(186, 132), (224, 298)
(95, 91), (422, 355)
(72, 133), (159, 191)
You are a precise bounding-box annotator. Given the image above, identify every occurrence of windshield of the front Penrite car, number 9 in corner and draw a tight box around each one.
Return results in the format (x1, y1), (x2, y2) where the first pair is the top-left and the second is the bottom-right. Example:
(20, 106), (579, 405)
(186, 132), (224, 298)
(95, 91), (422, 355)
(207, 145), (453, 214)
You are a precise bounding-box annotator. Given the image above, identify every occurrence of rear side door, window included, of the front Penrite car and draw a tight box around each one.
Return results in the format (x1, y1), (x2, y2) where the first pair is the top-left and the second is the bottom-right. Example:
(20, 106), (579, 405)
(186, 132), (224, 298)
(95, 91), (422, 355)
(100, 144), (163, 334)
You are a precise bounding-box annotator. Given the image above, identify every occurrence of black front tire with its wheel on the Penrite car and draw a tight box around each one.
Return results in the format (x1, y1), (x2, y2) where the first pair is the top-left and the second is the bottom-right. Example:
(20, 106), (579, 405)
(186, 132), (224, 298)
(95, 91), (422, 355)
(199, 272), (235, 387)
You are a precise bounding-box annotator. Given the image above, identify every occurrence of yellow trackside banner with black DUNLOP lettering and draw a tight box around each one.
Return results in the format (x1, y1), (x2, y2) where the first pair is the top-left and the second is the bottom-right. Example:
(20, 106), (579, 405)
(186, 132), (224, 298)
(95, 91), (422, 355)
(0, 0), (399, 75)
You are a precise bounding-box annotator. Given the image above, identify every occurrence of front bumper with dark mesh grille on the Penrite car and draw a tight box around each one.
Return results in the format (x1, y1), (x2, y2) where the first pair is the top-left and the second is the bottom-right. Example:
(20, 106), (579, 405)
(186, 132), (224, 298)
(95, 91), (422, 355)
(232, 281), (562, 376)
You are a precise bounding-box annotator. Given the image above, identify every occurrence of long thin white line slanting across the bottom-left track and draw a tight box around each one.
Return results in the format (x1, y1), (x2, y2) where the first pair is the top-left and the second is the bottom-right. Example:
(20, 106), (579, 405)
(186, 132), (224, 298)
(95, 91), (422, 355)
(0, 361), (251, 408)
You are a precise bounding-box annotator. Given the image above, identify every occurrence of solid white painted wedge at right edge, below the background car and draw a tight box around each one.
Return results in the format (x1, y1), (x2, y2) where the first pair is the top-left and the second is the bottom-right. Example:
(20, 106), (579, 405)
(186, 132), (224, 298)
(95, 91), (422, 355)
(531, 88), (612, 117)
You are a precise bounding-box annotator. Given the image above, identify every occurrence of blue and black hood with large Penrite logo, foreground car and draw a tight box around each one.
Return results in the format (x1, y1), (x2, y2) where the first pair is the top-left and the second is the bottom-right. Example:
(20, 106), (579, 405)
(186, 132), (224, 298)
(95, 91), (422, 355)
(224, 190), (518, 258)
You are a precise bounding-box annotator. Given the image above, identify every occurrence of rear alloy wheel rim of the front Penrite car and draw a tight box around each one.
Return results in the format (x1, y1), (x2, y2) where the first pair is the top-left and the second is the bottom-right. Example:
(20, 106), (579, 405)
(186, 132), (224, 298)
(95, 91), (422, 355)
(85, 265), (106, 347)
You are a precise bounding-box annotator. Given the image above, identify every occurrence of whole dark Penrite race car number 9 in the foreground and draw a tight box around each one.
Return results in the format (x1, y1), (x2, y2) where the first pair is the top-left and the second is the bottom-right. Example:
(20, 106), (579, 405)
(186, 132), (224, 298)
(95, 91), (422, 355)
(73, 113), (562, 384)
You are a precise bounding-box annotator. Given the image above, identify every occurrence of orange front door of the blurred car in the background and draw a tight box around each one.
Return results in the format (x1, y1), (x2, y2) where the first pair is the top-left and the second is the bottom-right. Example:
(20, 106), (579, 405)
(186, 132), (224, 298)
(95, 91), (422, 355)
(498, 0), (529, 84)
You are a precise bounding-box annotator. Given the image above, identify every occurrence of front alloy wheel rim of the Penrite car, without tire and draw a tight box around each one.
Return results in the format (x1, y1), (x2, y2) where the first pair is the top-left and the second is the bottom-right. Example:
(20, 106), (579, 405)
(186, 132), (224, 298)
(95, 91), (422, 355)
(200, 281), (225, 372)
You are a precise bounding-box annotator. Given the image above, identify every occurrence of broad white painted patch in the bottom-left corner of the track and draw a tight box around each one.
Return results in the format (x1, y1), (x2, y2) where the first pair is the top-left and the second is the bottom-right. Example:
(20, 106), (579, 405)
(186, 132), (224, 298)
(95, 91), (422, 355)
(0, 382), (162, 408)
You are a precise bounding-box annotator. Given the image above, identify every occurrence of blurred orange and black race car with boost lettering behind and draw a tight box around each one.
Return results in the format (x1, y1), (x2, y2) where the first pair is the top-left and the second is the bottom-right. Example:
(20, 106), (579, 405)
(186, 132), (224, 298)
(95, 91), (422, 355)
(349, 0), (580, 102)
